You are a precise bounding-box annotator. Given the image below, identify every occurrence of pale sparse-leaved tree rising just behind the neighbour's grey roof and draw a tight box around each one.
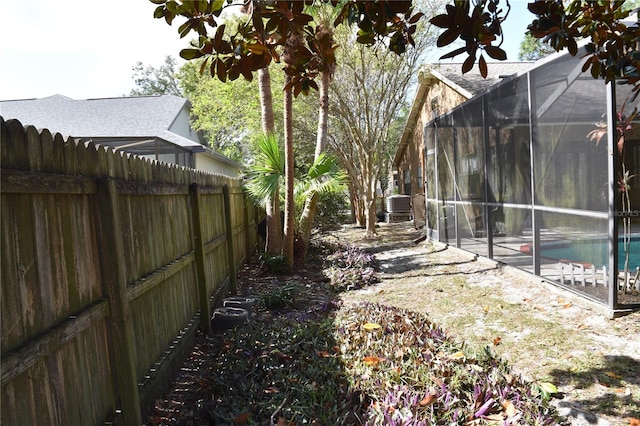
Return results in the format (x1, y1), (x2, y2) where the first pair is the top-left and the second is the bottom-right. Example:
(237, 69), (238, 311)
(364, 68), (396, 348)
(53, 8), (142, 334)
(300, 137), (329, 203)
(129, 56), (182, 96)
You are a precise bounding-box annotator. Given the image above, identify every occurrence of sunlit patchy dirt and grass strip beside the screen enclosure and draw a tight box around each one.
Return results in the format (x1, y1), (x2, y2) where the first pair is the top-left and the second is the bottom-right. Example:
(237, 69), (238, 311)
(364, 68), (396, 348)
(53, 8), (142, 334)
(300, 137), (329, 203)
(325, 222), (640, 425)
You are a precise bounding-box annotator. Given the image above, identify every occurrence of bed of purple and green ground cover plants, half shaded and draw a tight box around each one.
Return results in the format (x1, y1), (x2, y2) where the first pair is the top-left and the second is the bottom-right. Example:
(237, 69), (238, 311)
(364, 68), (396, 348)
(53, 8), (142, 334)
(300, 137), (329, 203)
(148, 238), (561, 425)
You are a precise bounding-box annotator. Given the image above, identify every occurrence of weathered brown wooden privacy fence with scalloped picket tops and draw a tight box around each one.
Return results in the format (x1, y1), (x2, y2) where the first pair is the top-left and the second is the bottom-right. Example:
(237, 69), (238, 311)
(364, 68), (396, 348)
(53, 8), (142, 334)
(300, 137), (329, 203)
(0, 118), (256, 426)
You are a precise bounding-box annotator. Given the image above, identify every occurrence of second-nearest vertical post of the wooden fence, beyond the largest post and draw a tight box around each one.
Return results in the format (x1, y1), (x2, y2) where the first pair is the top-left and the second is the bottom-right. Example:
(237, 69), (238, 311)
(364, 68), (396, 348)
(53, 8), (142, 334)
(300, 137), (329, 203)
(189, 183), (211, 336)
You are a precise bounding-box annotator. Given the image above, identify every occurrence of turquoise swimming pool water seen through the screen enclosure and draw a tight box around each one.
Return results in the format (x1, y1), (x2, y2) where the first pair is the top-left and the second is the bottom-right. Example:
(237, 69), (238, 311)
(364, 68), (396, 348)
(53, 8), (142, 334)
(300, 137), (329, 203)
(520, 234), (640, 271)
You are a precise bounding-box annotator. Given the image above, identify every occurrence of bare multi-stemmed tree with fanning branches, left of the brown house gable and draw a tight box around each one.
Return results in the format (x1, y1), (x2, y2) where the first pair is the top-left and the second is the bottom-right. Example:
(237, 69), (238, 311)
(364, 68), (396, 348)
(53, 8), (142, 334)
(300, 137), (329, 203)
(330, 2), (438, 236)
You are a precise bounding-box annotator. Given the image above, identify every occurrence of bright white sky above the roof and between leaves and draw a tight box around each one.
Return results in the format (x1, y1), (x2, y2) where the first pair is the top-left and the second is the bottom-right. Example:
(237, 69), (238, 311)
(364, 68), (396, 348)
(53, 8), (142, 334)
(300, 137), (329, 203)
(0, 0), (533, 100)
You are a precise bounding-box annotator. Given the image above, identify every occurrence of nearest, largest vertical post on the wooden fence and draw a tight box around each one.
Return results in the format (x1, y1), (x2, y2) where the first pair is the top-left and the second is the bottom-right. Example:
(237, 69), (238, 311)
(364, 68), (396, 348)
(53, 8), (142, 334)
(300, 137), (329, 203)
(96, 176), (142, 425)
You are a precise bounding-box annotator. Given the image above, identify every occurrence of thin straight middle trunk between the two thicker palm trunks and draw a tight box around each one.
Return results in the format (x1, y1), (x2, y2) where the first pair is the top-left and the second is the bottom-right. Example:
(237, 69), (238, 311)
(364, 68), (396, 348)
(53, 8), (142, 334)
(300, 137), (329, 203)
(282, 75), (296, 268)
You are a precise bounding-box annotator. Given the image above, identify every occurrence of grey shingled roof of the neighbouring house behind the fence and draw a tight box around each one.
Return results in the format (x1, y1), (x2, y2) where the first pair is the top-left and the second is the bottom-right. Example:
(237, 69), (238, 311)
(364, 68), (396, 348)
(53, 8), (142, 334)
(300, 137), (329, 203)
(0, 95), (204, 151)
